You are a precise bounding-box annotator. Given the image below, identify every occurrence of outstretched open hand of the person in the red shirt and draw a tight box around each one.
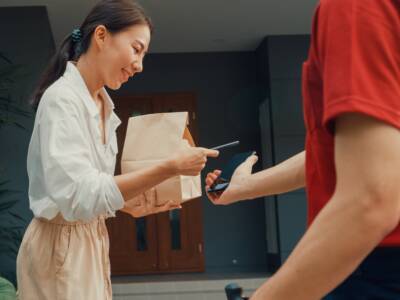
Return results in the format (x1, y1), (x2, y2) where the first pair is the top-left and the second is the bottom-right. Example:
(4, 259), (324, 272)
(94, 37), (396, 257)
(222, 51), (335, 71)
(206, 154), (258, 205)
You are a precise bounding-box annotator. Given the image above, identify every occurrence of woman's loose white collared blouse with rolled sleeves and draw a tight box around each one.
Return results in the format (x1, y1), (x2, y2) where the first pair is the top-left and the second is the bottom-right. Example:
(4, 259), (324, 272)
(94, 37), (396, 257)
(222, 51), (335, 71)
(27, 62), (124, 221)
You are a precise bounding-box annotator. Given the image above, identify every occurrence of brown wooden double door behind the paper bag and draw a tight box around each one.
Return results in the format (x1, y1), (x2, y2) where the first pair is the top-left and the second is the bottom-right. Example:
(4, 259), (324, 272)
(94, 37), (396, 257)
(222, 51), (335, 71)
(107, 93), (204, 275)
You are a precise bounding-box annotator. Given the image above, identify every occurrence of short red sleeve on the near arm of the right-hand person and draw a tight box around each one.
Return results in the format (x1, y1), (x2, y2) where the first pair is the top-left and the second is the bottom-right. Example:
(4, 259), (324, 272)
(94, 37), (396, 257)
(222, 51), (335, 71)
(314, 0), (400, 128)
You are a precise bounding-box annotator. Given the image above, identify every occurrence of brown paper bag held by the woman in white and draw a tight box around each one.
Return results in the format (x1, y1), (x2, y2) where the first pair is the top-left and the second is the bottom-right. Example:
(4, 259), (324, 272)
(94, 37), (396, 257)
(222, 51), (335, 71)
(121, 112), (202, 206)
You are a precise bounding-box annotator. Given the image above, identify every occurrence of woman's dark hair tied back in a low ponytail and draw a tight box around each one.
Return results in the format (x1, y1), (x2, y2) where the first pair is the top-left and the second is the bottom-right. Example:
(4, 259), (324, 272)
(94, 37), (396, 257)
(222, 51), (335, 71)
(32, 0), (153, 109)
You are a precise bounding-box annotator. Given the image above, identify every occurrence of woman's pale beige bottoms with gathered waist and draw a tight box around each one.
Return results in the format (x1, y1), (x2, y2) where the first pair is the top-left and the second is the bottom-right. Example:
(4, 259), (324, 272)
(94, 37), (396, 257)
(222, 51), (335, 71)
(17, 215), (112, 300)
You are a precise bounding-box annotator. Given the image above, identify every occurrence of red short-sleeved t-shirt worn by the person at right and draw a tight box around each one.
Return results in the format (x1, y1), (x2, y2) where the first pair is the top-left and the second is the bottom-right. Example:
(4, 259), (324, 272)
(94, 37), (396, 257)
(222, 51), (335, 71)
(302, 0), (400, 246)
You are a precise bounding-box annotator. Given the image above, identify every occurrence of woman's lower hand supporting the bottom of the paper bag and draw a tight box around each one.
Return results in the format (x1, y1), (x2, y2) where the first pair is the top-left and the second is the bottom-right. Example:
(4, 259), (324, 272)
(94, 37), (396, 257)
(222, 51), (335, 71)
(121, 189), (182, 218)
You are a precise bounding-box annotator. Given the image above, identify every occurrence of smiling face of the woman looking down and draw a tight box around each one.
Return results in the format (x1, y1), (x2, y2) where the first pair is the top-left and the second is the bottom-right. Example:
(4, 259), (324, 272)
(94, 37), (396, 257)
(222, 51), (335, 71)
(98, 25), (151, 90)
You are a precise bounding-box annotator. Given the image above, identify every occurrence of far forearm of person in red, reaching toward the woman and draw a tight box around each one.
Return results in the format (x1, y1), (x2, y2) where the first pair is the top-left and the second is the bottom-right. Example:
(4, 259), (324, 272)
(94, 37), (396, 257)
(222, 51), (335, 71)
(239, 151), (305, 199)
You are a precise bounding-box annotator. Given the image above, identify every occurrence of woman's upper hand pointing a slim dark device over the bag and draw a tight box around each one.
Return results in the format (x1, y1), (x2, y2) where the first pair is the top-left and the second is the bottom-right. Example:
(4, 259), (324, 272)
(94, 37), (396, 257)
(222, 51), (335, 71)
(170, 147), (219, 176)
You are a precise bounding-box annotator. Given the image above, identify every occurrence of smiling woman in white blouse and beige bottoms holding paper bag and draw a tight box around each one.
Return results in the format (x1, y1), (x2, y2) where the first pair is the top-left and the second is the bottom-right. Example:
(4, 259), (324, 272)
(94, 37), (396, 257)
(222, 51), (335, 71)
(17, 0), (218, 300)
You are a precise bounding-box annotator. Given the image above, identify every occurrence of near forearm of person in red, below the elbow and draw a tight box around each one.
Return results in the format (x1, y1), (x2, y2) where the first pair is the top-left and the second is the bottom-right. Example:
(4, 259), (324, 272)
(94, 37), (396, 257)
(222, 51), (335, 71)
(252, 192), (395, 300)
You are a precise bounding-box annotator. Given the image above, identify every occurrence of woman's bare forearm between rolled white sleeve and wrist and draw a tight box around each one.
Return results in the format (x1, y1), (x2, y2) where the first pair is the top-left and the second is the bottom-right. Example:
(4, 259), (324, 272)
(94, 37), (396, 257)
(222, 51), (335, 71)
(114, 161), (176, 201)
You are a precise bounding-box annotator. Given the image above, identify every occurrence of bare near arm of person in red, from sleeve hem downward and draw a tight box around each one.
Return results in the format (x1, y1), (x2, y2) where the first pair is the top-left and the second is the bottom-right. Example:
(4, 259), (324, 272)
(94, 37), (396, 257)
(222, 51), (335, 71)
(252, 114), (400, 300)
